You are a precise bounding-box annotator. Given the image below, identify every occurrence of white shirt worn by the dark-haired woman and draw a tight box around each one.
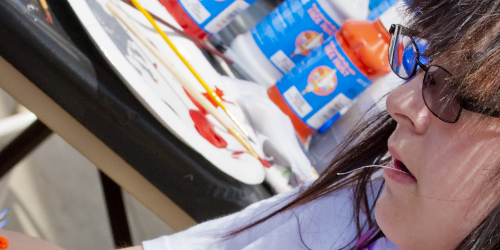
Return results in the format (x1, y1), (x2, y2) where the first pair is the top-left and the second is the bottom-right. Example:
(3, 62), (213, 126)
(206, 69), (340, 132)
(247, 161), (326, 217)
(143, 181), (398, 250)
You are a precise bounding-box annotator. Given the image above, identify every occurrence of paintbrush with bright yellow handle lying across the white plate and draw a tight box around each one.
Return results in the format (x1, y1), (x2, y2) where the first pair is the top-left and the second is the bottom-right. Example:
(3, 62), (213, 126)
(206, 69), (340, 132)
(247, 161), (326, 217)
(131, 0), (251, 141)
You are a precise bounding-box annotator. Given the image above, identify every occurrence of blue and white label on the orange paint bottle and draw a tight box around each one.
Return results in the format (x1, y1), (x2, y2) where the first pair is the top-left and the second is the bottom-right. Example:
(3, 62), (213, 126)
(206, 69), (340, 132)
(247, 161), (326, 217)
(276, 36), (372, 130)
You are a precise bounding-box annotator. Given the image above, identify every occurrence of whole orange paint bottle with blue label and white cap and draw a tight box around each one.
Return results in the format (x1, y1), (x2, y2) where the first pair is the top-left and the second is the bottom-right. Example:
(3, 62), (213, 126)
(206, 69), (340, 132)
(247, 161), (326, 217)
(268, 5), (399, 142)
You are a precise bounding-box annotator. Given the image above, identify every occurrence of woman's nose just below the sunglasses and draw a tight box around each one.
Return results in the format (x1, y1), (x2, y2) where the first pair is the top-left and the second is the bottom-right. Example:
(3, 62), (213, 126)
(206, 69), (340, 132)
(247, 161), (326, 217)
(386, 74), (432, 134)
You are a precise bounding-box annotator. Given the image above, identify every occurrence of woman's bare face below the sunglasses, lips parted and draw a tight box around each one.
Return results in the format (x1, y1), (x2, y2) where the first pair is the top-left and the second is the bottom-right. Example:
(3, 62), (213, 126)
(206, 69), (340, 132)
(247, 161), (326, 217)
(375, 73), (500, 250)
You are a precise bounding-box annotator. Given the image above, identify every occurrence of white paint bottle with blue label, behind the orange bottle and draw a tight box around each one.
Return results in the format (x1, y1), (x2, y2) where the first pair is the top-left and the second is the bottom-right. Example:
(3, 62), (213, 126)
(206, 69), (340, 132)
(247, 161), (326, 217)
(226, 0), (369, 87)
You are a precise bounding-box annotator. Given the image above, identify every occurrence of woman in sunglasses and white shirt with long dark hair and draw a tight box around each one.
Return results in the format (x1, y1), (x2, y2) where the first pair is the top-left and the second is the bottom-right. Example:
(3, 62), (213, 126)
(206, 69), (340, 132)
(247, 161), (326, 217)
(125, 0), (500, 250)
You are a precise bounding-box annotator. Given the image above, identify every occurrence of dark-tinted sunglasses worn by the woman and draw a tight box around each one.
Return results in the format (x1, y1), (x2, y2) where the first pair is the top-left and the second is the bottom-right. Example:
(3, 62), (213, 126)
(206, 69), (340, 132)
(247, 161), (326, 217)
(389, 24), (500, 123)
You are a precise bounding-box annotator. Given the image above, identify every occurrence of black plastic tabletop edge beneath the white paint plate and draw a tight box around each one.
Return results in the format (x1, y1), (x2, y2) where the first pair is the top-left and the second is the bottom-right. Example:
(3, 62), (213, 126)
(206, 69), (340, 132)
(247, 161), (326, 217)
(0, 0), (270, 222)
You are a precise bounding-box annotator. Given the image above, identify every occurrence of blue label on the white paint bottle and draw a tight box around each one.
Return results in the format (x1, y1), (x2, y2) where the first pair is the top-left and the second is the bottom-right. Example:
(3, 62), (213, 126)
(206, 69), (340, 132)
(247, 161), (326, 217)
(251, 0), (341, 73)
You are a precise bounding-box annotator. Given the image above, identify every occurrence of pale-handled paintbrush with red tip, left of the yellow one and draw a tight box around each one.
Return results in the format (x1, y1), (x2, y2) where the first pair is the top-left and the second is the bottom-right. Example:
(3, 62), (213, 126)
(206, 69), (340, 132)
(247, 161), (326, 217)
(106, 2), (271, 167)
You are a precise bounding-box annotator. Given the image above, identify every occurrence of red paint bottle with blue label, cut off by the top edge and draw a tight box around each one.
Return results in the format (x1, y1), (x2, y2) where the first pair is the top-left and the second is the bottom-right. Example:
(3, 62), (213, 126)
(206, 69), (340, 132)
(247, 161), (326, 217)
(159, 0), (256, 39)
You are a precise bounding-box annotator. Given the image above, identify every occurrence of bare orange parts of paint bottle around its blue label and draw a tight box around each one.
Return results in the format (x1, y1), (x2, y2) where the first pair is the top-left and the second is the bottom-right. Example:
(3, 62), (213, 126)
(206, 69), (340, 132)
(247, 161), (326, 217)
(267, 19), (391, 142)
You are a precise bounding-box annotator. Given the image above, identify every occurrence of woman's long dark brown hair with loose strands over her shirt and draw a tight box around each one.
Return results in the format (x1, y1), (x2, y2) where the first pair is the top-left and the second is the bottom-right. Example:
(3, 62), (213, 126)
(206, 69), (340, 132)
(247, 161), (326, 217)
(228, 0), (500, 249)
